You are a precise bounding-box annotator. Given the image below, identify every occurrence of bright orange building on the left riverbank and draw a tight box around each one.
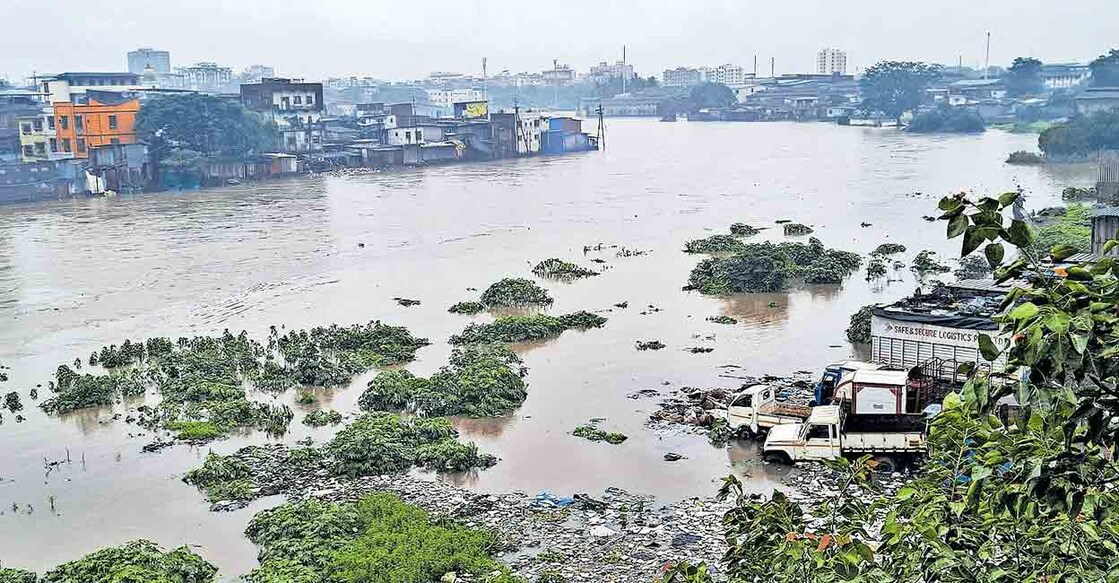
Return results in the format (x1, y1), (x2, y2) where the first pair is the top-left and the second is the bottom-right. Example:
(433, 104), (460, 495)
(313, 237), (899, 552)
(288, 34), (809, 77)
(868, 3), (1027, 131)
(51, 91), (140, 158)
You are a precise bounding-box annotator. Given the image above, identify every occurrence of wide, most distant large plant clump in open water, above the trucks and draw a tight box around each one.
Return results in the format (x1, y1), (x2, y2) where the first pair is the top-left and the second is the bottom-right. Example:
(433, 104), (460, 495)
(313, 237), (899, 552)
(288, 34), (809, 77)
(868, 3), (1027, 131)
(688, 237), (863, 295)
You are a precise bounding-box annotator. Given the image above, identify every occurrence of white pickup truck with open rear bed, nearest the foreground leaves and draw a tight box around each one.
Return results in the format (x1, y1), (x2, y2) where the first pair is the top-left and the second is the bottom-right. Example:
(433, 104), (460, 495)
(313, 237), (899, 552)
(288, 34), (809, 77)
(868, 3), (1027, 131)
(762, 405), (928, 472)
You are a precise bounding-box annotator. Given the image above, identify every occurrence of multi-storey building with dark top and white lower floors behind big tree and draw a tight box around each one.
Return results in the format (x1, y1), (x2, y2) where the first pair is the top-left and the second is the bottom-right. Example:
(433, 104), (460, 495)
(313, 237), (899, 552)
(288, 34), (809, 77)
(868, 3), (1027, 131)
(241, 78), (326, 153)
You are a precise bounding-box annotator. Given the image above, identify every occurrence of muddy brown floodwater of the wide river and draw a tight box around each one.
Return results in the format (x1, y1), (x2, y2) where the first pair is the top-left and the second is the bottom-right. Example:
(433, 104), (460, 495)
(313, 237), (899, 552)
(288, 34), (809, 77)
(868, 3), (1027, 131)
(0, 121), (1091, 574)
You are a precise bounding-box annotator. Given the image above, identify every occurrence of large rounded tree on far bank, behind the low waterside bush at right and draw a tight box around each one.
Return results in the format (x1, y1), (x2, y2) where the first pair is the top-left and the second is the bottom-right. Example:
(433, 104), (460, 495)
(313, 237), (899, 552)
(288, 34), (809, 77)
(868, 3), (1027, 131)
(859, 60), (940, 121)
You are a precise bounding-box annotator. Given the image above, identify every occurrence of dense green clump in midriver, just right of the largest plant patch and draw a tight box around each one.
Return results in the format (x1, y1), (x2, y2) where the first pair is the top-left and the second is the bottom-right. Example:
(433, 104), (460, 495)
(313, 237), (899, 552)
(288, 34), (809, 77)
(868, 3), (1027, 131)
(358, 345), (528, 417)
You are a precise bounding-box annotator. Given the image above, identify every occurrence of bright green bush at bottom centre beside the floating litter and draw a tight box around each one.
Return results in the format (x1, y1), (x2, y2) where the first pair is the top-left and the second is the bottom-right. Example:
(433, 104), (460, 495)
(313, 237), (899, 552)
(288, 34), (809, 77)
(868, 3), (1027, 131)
(245, 493), (517, 583)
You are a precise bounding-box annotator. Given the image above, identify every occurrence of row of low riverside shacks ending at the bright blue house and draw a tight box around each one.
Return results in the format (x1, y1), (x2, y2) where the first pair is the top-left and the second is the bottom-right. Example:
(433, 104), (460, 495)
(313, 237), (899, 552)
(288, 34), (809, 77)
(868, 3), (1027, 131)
(328, 101), (598, 168)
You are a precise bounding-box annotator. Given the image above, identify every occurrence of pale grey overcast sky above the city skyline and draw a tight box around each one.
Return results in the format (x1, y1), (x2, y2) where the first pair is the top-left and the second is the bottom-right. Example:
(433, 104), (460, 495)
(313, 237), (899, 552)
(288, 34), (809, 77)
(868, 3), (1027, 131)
(0, 0), (1119, 81)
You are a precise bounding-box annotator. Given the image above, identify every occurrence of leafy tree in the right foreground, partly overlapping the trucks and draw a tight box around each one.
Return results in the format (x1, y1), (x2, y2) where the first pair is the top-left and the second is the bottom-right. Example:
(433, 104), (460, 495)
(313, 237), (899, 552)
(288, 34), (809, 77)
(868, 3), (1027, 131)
(665, 192), (1119, 583)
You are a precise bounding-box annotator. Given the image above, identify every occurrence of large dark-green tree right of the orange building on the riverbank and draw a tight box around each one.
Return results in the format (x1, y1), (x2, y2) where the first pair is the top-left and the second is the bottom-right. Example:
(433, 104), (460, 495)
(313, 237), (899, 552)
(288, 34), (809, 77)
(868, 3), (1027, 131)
(137, 94), (279, 157)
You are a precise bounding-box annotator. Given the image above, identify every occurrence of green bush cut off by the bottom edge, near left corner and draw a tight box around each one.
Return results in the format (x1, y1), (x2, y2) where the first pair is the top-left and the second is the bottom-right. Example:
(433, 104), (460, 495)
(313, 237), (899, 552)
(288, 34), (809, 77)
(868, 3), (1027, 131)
(40, 540), (217, 583)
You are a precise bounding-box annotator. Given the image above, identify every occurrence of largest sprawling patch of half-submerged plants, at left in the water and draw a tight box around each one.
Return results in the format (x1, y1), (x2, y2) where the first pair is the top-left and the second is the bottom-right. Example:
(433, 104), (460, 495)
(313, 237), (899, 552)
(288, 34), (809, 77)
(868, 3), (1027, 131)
(34, 321), (429, 441)
